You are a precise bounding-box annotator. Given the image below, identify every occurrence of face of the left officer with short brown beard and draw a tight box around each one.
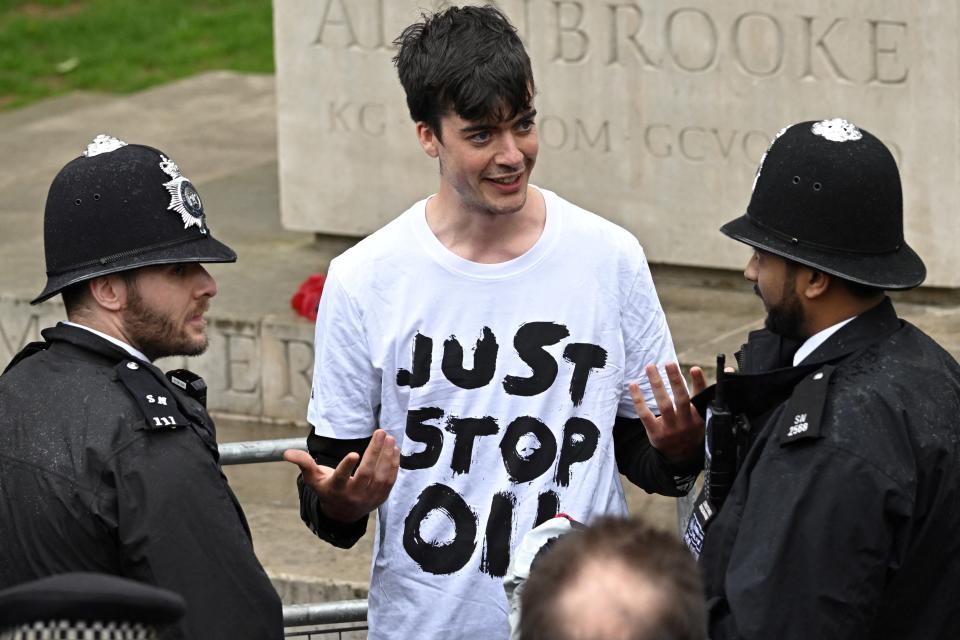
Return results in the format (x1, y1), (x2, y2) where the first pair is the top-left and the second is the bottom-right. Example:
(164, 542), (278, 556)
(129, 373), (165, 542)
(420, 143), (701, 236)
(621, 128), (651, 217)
(123, 262), (217, 360)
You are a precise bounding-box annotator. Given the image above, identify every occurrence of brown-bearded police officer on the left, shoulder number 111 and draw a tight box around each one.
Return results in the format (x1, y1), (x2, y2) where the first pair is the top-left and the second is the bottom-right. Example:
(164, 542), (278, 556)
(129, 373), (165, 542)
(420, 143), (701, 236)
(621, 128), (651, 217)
(0, 136), (283, 639)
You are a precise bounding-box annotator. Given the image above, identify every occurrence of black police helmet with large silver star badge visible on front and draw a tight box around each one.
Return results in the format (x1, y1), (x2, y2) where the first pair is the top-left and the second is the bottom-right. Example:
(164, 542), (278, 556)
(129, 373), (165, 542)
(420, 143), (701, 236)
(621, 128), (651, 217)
(32, 135), (237, 304)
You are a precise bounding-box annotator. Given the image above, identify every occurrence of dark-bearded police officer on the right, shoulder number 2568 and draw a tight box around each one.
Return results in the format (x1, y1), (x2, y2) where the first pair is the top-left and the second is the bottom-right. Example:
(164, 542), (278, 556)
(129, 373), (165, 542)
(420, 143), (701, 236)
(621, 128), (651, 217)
(647, 119), (960, 640)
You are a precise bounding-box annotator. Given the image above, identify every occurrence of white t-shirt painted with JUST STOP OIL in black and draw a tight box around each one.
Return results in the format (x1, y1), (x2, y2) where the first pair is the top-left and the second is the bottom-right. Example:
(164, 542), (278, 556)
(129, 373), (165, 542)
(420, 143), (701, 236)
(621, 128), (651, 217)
(307, 189), (676, 640)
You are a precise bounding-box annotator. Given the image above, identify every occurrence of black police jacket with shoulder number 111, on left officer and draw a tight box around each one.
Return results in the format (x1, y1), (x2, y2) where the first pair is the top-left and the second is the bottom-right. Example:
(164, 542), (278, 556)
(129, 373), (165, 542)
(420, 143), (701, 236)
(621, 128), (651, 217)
(0, 324), (283, 640)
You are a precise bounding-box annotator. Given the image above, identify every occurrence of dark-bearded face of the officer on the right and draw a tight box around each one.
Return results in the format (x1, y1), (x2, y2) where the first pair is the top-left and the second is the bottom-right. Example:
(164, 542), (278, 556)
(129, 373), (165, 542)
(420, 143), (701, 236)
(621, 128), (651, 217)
(743, 249), (809, 339)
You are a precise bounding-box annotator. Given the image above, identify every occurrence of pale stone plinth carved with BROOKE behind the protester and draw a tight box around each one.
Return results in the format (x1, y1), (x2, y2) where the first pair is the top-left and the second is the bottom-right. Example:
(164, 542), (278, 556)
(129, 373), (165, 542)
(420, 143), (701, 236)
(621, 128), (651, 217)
(274, 0), (960, 287)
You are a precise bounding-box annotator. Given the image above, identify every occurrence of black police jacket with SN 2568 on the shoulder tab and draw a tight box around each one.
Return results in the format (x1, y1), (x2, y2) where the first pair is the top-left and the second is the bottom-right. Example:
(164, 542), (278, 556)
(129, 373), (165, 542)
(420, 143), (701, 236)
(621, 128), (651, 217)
(700, 299), (960, 640)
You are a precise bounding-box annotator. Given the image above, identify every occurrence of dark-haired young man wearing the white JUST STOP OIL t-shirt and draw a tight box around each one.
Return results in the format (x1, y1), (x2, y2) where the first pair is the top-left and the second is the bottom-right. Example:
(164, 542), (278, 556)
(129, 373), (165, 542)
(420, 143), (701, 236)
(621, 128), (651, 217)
(287, 7), (702, 638)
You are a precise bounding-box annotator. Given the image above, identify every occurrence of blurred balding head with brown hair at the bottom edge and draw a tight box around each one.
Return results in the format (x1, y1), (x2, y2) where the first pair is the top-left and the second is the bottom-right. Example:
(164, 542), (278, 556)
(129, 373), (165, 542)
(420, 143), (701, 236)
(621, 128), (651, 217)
(517, 517), (707, 640)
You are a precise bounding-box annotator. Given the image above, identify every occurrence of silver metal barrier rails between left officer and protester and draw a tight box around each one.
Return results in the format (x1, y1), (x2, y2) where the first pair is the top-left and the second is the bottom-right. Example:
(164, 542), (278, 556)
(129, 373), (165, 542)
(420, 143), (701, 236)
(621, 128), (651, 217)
(219, 438), (367, 640)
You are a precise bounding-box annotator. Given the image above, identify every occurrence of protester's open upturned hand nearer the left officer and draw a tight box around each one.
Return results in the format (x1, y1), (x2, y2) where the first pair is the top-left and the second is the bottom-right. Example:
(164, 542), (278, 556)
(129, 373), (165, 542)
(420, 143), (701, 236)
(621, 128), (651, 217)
(283, 429), (400, 522)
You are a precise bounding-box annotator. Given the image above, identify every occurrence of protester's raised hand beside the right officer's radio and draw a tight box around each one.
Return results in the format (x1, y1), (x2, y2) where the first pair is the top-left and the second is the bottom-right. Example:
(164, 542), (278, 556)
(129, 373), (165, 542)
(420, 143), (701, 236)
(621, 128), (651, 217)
(629, 362), (707, 461)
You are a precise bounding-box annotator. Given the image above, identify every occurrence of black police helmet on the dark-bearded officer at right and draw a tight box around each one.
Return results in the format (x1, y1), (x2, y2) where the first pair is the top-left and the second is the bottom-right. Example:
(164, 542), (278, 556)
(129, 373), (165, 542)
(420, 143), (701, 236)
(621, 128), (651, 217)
(720, 118), (927, 289)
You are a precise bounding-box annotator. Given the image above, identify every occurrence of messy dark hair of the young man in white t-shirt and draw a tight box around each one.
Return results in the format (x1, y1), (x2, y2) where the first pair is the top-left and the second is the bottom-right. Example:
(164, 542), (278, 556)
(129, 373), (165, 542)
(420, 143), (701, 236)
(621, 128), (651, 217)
(393, 5), (534, 140)
